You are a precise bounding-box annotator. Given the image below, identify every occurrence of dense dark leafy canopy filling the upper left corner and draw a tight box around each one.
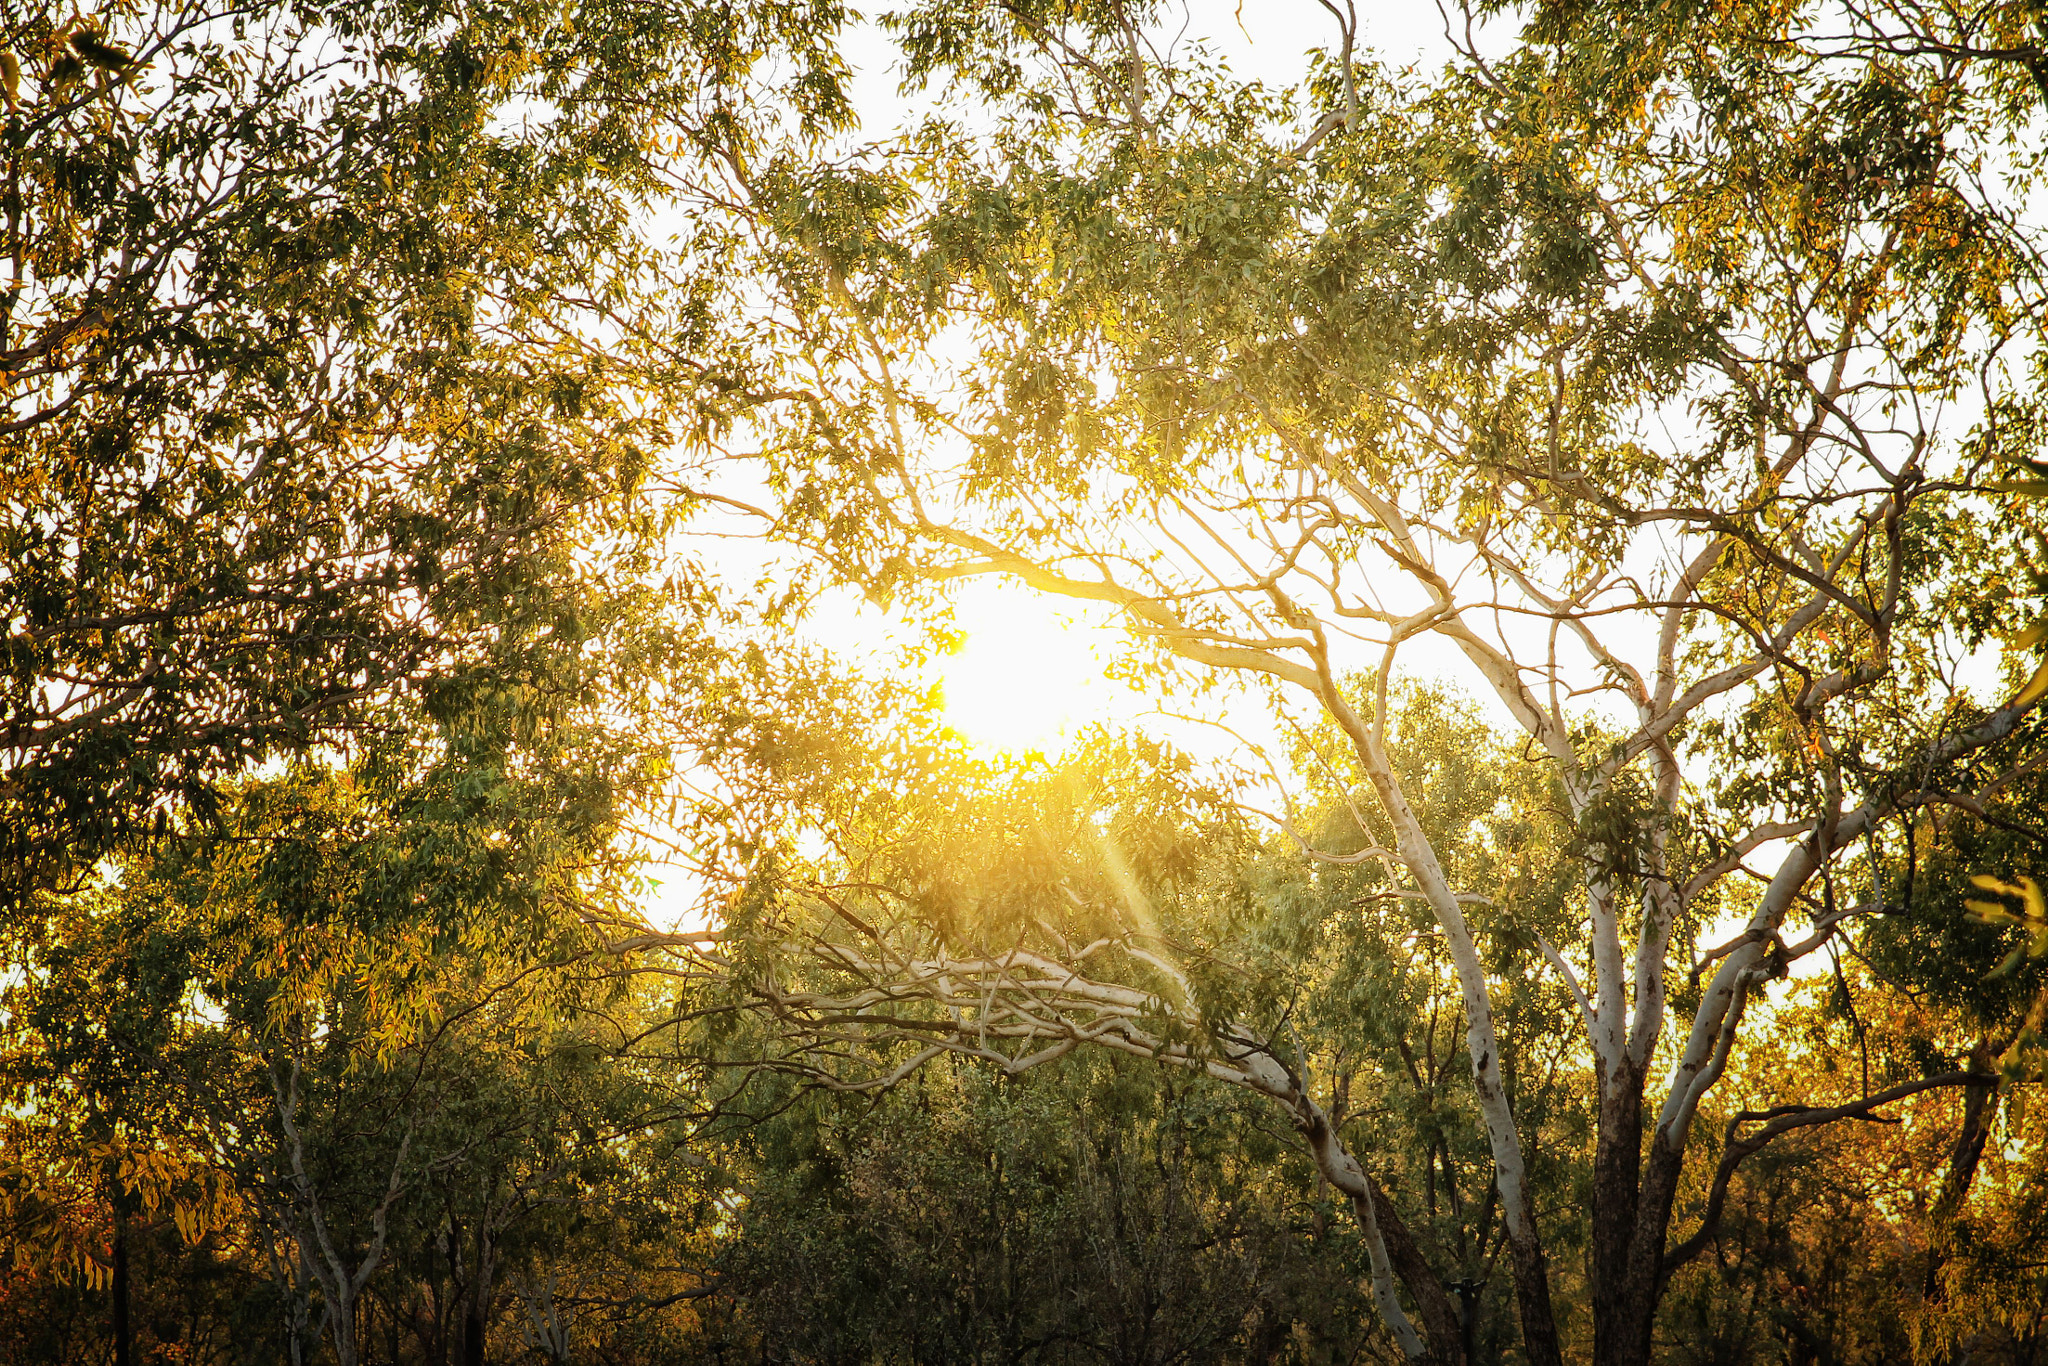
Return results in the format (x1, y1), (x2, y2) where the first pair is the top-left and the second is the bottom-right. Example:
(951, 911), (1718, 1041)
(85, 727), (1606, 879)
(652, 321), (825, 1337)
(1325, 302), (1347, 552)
(0, 0), (838, 917)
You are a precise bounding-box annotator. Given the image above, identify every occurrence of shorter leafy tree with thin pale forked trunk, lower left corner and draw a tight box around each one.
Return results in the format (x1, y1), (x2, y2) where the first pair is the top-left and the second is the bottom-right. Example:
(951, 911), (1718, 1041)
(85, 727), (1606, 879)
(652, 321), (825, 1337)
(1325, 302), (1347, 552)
(0, 733), (729, 1362)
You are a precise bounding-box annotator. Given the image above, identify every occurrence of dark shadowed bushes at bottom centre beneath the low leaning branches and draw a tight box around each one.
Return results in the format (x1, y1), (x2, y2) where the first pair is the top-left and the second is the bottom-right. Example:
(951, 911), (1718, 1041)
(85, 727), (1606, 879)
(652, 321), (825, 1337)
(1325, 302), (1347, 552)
(694, 1040), (1366, 1364)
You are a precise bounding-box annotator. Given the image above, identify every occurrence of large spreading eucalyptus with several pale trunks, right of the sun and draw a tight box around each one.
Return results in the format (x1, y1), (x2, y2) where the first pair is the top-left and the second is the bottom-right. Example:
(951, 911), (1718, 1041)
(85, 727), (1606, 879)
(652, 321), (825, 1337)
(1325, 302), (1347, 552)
(643, 0), (2042, 1366)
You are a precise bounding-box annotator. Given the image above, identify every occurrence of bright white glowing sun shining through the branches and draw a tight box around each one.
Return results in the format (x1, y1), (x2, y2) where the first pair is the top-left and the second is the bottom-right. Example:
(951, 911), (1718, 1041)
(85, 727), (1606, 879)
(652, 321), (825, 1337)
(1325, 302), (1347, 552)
(938, 584), (1145, 754)
